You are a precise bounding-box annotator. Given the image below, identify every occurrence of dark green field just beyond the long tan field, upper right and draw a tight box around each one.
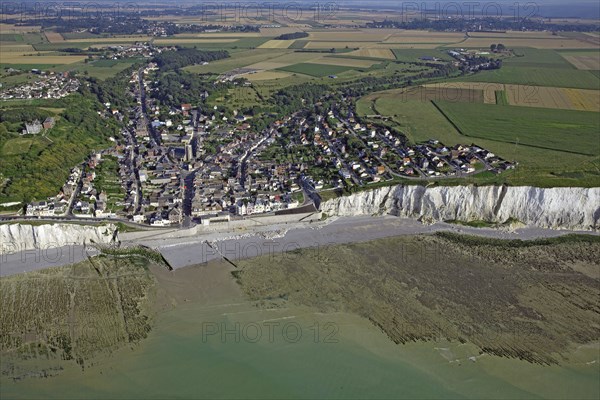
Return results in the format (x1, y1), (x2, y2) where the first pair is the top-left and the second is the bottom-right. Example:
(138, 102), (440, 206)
(456, 65), (600, 90)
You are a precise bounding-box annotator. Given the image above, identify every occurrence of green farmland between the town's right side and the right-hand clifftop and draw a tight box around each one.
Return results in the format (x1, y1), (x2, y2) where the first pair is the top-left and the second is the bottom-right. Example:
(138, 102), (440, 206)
(357, 86), (600, 186)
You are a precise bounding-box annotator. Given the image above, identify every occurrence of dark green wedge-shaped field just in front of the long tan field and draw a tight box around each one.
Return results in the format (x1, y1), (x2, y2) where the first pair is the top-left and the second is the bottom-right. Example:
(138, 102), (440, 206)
(436, 101), (600, 156)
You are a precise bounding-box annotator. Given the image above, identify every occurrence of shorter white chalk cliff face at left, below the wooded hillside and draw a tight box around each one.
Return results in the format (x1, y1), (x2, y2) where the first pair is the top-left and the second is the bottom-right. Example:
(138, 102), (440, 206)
(0, 224), (117, 254)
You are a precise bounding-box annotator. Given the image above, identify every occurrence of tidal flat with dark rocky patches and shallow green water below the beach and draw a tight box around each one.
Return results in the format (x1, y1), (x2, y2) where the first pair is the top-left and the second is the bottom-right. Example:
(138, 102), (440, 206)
(0, 234), (600, 399)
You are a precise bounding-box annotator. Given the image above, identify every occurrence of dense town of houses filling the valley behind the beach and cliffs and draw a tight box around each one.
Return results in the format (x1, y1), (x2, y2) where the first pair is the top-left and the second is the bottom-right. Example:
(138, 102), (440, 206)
(21, 56), (514, 227)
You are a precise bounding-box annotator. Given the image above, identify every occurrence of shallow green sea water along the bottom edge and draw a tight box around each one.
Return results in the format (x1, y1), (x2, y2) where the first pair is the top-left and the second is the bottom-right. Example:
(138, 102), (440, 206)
(0, 302), (600, 399)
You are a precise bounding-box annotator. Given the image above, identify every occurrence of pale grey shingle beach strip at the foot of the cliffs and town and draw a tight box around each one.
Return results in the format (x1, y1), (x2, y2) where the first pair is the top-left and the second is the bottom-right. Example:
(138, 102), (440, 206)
(0, 215), (600, 277)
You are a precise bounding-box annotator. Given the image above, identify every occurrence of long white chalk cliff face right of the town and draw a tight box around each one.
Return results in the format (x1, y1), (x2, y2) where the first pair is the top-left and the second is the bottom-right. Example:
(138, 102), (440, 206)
(321, 186), (600, 230)
